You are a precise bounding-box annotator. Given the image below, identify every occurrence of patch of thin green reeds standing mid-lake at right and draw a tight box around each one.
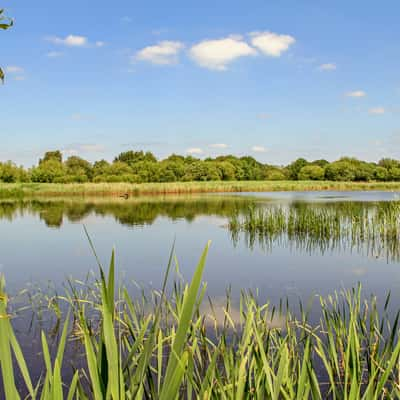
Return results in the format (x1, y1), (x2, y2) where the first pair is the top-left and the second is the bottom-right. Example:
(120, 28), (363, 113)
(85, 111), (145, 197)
(228, 201), (400, 261)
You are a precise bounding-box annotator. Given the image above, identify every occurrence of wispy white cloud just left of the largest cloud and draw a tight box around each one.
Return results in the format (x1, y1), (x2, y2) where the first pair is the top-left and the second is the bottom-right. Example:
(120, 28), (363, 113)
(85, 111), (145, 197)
(133, 40), (184, 65)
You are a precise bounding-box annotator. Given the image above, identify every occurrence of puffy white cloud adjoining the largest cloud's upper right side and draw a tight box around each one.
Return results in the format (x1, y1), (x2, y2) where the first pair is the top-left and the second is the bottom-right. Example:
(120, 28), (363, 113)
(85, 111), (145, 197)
(250, 32), (296, 57)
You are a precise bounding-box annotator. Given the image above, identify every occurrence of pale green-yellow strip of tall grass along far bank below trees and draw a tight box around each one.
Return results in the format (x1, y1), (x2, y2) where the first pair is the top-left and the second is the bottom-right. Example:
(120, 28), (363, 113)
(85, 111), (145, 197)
(0, 181), (400, 198)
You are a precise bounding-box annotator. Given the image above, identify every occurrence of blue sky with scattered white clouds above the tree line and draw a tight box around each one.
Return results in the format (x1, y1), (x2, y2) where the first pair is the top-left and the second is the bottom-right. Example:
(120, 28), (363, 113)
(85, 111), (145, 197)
(0, 0), (400, 166)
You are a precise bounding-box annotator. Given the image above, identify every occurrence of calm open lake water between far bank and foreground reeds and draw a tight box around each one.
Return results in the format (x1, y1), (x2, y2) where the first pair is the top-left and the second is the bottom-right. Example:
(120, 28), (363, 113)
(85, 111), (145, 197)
(0, 192), (400, 302)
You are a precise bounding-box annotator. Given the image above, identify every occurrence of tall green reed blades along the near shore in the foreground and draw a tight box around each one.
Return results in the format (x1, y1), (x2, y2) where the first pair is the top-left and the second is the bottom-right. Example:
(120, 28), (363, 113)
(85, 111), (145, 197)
(0, 245), (400, 400)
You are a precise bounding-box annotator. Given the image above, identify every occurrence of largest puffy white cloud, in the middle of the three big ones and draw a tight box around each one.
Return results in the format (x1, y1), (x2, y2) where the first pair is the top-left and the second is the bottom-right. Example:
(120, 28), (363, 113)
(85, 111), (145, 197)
(190, 36), (257, 71)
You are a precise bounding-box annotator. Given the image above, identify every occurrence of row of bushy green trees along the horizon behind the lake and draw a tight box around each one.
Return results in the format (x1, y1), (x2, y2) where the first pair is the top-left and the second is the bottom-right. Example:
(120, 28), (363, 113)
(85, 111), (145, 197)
(0, 150), (400, 183)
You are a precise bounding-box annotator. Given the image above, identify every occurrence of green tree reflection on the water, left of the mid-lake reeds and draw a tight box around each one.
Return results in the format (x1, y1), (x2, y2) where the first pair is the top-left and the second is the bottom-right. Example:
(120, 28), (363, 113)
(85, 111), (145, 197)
(0, 196), (252, 228)
